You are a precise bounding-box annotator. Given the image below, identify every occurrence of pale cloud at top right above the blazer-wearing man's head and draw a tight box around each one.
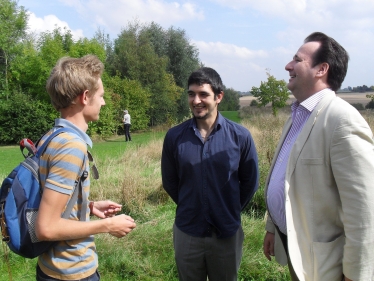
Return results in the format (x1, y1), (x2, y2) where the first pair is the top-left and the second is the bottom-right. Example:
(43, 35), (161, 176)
(211, 0), (374, 30)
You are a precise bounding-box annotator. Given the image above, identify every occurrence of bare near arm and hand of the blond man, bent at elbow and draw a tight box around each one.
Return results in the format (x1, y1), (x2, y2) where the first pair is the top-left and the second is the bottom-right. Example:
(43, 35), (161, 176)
(35, 188), (136, 241)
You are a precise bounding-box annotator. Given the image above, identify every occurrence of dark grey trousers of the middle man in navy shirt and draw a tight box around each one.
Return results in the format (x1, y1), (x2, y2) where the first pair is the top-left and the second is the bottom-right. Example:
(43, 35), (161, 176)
(173, 224), (244, 281)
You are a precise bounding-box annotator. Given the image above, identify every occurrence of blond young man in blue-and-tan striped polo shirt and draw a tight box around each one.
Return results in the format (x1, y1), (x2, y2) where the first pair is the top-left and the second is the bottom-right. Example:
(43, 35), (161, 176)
(36, 55), (136, 281)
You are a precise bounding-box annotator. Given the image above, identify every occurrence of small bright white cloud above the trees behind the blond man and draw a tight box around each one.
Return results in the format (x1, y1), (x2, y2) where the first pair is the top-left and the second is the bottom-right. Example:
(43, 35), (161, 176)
(28, 12), (84, 40)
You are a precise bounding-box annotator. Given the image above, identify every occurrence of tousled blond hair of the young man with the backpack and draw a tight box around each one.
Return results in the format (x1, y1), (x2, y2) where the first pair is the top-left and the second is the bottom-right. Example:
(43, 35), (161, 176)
(46, 55), (104, 110)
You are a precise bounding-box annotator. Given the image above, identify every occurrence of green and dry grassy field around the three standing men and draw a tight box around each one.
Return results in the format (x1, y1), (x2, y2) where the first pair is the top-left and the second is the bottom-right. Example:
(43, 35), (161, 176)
(0, 112), (289, 281)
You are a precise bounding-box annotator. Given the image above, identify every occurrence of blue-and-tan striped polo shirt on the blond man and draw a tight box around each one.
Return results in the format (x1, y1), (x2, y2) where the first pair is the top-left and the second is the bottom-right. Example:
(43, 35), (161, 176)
(38, 119), (98, 280)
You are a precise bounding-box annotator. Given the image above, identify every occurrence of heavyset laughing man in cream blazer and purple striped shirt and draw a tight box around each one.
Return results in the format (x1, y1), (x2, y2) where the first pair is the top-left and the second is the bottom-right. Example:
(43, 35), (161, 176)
(264, 32), (374, 281)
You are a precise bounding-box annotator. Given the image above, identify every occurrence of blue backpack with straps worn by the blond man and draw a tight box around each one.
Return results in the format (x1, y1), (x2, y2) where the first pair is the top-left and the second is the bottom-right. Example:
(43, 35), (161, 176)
(0, 128), (88, 259)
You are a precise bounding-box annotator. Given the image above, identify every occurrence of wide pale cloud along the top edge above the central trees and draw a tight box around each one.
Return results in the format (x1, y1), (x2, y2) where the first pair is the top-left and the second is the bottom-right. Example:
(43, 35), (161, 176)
(60, 0), (204, 34)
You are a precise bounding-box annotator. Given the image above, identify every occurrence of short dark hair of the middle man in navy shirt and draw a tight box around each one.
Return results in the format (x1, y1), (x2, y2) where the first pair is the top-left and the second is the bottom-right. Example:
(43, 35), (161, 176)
(187, 67), (223, 96)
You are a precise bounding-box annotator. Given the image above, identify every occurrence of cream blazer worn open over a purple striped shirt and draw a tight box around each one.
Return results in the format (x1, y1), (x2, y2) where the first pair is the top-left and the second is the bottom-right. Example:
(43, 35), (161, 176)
(265, 92), (374, 281)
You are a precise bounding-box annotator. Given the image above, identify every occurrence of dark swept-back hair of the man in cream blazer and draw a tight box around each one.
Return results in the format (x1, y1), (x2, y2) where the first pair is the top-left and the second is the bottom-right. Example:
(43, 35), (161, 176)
(304, 32), (349, 91)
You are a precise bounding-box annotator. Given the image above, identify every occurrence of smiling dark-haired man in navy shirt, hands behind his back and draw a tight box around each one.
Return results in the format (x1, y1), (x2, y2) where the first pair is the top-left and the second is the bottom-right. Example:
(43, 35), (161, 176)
(161, 67), (258, 281)
